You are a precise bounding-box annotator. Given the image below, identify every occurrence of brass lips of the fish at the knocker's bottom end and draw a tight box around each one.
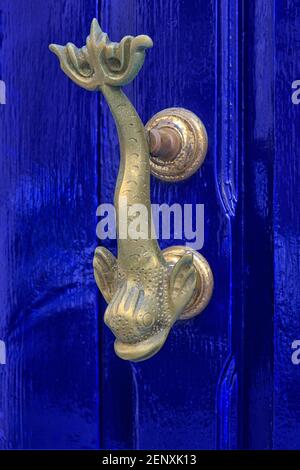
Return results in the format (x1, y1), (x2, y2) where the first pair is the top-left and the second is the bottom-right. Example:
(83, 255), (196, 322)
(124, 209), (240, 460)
(115, 329), (170, 362)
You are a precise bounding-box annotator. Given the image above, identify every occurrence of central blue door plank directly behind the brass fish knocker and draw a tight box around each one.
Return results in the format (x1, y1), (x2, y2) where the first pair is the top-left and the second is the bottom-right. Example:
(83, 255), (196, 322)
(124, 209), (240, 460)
(100, 0), (235, 449)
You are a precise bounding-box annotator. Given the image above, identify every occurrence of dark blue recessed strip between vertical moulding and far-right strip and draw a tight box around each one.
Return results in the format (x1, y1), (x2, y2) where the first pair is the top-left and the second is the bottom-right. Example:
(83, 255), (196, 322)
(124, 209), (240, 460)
(240, 0), (275, 449)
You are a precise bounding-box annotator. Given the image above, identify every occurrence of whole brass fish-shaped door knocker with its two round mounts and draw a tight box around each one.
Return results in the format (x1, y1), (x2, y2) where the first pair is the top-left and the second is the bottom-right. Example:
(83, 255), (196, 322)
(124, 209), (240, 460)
(50, 19), (213, 361)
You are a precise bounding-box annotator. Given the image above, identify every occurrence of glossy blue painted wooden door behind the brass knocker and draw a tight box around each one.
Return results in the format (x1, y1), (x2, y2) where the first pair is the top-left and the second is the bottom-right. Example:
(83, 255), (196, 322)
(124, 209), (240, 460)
(0, 0), (300, 449)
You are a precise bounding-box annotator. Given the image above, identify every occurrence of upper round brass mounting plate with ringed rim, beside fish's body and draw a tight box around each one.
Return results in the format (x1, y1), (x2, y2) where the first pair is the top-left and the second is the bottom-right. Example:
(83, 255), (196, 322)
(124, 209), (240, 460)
(145, 108), (208, 182)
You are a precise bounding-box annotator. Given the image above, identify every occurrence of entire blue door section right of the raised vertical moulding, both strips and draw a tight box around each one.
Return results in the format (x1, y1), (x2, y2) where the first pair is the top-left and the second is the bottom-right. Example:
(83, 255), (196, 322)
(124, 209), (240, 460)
(241, 0), (300, 449)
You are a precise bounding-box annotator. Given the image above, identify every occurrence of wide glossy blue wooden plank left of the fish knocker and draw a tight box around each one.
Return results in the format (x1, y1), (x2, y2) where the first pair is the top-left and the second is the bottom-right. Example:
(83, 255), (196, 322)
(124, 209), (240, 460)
(0, 0), (98, 449)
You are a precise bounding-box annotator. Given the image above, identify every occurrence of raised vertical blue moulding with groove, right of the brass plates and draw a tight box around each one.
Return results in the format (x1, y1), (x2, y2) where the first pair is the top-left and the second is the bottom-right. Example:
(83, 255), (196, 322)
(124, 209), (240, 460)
(215, 0), (243, 449)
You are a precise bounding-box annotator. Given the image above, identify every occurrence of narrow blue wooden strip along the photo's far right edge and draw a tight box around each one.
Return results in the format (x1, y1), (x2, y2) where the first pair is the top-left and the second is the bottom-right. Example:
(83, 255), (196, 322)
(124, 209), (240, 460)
(273, 0), (300, 449)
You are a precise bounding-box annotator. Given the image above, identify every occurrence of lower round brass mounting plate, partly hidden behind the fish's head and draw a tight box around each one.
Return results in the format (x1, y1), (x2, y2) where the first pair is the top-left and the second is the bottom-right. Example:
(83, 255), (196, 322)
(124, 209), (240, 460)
(162, 246), (214, 320)
